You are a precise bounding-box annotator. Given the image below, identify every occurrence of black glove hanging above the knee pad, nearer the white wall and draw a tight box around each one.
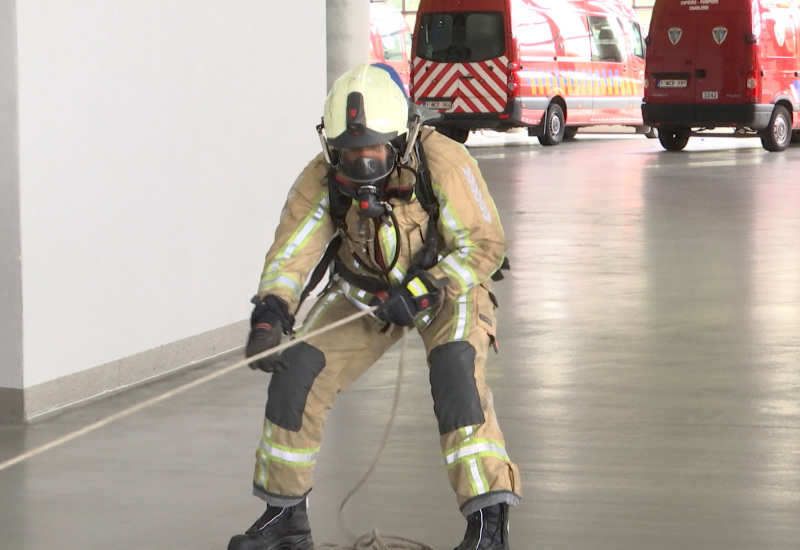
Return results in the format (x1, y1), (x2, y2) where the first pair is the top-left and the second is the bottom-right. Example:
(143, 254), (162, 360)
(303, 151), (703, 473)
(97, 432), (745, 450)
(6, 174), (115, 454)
(244, 294), (294, 372)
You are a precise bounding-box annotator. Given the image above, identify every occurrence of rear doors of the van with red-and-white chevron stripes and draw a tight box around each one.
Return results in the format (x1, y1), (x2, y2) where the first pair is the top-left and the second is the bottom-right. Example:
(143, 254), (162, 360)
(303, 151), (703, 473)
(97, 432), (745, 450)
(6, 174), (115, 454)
(412, 0), (509, 113)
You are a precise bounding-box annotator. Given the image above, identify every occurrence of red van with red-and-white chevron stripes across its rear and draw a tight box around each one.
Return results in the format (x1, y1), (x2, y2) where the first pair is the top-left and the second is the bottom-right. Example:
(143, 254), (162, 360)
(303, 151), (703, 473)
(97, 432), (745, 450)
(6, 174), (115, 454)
(411, 0), (649, 145)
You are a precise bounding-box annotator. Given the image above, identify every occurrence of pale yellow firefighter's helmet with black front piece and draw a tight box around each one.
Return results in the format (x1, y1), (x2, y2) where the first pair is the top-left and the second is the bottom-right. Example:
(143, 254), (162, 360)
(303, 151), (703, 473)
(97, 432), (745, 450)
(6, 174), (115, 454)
(322, 64), (408, 149)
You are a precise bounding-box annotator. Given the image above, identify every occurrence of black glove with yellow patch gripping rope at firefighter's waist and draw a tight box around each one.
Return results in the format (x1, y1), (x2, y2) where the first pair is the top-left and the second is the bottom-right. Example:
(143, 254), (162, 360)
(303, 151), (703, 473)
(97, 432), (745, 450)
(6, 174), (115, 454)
(369, 270), (441, 327)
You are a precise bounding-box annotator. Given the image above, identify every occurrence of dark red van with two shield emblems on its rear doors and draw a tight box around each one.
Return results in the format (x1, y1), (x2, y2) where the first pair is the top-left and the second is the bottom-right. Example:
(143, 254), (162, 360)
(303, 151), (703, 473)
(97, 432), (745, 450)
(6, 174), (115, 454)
(642, 0), (800, 151)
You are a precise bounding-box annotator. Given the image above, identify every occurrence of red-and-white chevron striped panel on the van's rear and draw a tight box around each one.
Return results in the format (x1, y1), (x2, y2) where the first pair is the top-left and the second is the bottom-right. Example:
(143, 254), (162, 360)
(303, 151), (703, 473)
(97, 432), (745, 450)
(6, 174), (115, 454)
(411, 57), (508, 113)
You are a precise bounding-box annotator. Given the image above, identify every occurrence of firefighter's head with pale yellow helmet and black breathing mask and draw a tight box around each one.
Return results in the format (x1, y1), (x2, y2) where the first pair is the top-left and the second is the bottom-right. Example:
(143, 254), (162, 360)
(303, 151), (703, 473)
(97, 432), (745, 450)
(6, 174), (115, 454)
(317, 65), (420, 218)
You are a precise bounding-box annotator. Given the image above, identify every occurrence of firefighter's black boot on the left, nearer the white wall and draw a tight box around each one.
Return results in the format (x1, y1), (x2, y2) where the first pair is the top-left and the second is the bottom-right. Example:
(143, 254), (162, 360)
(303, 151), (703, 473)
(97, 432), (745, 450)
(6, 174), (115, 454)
(228, 500), (314, 550)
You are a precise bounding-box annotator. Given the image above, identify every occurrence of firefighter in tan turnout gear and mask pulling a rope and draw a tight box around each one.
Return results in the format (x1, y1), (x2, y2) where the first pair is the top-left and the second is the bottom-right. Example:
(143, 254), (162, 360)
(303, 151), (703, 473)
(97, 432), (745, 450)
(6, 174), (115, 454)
(228, 65), (521, 550)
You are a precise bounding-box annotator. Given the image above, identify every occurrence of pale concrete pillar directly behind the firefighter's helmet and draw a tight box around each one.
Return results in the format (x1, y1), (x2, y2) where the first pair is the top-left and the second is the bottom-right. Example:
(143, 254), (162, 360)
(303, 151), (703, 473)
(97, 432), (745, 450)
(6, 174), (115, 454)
(326, 0), (369, 90)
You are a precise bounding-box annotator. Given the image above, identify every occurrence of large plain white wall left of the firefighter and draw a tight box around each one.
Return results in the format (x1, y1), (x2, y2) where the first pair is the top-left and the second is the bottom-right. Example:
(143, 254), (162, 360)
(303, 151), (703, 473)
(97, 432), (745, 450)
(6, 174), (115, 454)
(0, 0), (326, 402)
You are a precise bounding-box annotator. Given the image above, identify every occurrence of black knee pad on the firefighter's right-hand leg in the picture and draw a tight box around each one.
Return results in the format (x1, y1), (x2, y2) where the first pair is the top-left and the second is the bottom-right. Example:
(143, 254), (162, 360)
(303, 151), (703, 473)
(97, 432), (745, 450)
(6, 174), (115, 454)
(428, 341), (484, 435)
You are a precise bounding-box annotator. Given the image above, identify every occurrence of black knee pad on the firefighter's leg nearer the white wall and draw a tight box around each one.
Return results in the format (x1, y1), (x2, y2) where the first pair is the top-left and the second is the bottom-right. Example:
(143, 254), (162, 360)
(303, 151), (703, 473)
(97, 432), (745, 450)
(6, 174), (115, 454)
(264, 342), (325, 432)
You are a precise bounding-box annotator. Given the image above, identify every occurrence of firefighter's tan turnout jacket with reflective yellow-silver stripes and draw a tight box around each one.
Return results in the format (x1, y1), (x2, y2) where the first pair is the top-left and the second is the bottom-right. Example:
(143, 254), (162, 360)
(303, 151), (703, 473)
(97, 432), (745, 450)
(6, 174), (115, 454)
(258, 129), (506, 328)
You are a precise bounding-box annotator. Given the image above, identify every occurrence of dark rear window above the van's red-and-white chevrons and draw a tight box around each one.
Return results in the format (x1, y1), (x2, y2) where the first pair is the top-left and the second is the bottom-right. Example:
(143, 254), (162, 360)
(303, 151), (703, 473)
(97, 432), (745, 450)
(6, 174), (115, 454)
(416, 11), (505, 63)
